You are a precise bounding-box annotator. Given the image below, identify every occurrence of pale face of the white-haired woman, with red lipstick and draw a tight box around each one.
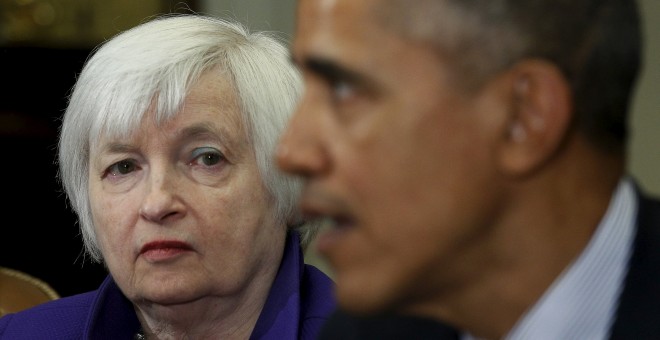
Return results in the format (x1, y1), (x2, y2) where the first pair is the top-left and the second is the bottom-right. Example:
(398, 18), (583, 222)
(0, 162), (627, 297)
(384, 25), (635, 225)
(90, 72), (286, 304)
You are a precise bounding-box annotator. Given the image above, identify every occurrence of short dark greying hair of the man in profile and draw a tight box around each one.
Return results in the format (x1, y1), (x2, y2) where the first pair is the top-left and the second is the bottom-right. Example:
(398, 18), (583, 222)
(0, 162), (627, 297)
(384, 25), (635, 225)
(377, 0), (642, 152)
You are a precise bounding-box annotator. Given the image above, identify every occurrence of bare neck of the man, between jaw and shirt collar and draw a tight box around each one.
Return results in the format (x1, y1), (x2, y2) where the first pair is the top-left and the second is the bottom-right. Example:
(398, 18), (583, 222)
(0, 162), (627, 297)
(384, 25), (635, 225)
(411, 139), (623, 339)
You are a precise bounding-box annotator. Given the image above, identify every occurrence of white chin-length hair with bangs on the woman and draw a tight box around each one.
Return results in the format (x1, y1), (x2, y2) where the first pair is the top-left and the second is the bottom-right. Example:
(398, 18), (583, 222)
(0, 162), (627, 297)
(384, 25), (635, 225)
(59, 14), (318, 261)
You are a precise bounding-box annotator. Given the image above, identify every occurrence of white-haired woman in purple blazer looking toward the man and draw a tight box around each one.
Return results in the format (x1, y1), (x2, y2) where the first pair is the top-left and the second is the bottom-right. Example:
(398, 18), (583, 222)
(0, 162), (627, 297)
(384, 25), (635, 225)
(0, 15), (334, 340)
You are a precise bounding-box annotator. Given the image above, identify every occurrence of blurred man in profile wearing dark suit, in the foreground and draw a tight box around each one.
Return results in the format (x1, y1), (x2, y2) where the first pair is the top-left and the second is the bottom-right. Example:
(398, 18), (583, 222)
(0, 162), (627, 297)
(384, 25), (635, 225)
(278, 0), (660, 339)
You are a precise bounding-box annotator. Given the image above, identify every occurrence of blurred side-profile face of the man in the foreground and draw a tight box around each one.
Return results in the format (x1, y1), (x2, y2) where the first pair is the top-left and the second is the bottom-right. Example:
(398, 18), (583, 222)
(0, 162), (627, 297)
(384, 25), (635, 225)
(278, 0), (508, 312)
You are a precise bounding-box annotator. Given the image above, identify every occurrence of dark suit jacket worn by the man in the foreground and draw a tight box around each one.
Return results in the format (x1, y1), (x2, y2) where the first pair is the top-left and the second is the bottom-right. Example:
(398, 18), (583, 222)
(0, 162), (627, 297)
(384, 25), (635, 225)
(319, 187), (660, 340)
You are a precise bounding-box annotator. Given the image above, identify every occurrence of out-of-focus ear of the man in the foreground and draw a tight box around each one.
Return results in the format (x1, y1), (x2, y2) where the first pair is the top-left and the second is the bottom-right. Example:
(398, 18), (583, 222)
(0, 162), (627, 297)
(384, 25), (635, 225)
(499, 59), (573, 176)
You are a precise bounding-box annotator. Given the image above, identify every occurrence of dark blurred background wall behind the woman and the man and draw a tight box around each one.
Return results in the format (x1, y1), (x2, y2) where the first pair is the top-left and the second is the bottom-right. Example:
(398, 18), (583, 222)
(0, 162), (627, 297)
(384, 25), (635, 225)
(0, 0), (660, 296)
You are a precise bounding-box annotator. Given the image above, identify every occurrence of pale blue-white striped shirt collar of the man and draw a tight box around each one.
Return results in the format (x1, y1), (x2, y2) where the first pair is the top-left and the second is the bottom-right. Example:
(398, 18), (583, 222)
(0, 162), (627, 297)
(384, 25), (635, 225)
(463, 178), (638, 340)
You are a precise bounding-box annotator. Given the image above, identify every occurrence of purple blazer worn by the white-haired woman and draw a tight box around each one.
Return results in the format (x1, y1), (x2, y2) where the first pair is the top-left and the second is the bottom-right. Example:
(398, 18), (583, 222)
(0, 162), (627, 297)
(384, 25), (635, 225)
(0, 233), (335, 340)
